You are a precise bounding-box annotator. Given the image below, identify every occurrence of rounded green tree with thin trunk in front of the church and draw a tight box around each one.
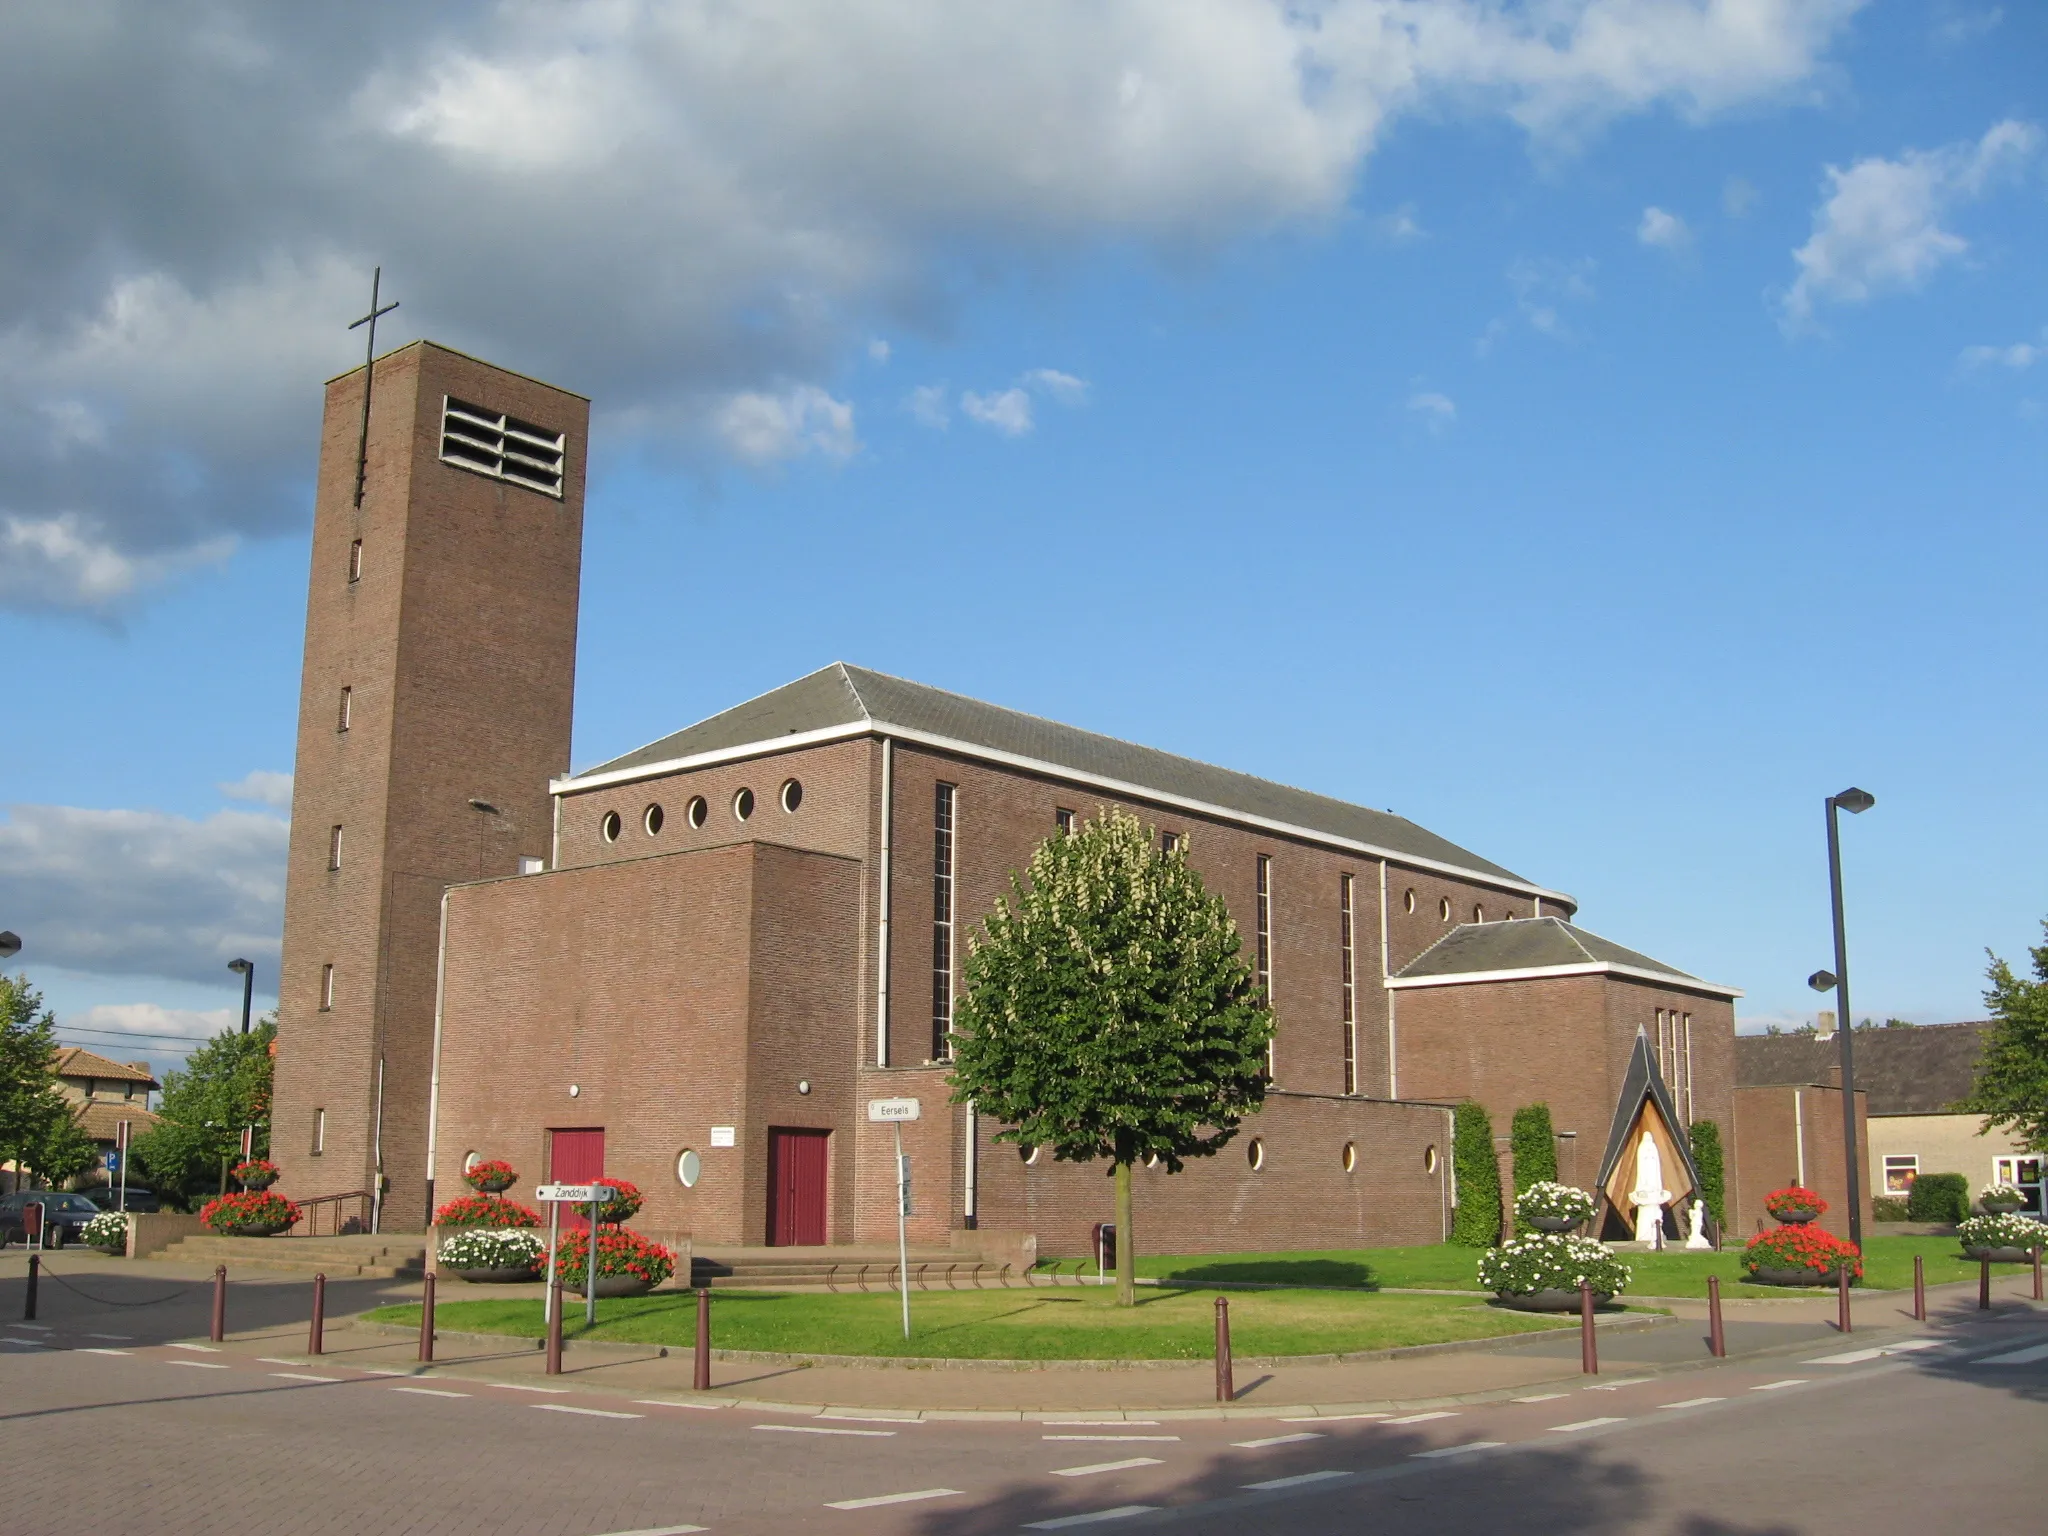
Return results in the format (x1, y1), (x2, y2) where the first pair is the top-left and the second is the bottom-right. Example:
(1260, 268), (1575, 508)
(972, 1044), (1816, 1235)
(952, 811), (1272, 1307)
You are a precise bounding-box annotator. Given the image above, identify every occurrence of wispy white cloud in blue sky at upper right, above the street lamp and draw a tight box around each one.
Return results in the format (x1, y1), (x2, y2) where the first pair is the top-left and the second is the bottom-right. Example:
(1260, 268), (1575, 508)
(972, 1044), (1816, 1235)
(1782, 119), (2042, 330)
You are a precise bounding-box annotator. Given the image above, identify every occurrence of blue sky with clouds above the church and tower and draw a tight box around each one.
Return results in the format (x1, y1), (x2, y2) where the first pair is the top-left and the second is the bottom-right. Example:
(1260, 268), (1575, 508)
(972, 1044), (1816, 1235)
(0, 0), (2048, 1061)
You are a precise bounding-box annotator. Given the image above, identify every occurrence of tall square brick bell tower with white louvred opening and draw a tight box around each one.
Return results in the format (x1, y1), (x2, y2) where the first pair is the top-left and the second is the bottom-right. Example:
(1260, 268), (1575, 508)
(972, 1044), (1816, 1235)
(270, 342), (590, 1231)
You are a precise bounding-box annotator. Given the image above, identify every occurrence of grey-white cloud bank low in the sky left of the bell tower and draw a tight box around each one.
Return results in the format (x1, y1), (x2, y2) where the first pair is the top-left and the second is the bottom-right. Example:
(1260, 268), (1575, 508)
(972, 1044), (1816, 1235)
(0, 805), (289, 987)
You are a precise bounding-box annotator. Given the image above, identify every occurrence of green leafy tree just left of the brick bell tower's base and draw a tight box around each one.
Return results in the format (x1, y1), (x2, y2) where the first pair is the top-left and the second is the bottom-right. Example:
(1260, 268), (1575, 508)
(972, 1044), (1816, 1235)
(133, 1014), (276, 1198)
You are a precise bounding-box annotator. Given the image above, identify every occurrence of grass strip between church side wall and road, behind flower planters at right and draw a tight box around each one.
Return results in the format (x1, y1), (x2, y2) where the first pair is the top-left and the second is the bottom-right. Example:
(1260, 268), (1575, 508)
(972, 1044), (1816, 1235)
(1138, 1229), (2019, 1296)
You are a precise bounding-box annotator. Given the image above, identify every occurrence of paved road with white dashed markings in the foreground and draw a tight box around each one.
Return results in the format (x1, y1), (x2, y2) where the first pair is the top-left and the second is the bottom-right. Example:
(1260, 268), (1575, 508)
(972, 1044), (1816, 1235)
(0, 1313), (2048, 1536)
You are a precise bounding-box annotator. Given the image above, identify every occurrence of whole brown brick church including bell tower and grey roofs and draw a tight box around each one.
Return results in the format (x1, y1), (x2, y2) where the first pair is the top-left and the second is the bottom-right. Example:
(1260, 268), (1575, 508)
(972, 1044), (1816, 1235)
(272, 342), (1739, 1253)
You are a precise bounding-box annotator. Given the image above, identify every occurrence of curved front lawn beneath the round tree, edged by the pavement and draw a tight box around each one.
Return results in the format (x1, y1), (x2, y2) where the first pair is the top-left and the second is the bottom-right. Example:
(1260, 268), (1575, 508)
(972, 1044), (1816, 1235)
(369, 1286), (1577, 1360)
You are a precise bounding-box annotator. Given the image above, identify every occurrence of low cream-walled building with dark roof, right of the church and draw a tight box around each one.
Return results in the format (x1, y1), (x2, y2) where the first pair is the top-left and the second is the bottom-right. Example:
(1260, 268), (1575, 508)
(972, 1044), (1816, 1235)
(1735, 1020), (2042, 1212)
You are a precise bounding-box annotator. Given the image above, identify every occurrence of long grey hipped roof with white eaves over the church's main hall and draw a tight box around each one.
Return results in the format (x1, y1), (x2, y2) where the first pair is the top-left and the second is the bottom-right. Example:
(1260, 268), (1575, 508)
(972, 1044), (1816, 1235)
(553, 662), (1577, 905)
